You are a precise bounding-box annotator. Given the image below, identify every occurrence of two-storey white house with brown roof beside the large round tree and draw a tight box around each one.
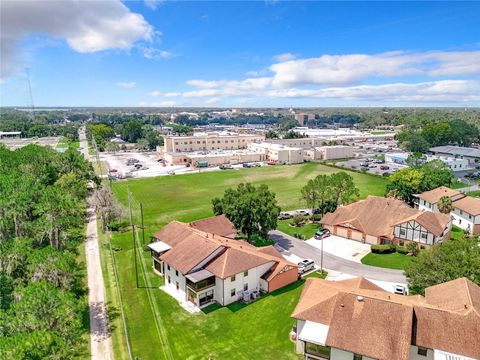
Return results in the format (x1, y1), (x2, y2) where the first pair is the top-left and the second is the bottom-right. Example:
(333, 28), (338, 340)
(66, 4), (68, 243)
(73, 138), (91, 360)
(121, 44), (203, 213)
(148, 215), (298, 309)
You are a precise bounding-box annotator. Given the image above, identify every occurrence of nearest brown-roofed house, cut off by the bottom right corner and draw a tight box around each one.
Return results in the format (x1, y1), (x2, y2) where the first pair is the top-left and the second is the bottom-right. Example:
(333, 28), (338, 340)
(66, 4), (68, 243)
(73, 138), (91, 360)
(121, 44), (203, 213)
(292, 278), (480, 360)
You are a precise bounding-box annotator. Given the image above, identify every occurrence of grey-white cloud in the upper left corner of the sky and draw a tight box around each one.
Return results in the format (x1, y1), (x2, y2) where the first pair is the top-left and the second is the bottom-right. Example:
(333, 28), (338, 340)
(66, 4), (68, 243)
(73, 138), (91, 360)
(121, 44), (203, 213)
(0, 0), (154, 77)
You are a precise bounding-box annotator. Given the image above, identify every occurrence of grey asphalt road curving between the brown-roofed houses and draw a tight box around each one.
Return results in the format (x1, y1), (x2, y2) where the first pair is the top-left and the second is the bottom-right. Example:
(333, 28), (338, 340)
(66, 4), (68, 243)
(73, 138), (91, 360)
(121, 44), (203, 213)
(269, 230), (407, 284)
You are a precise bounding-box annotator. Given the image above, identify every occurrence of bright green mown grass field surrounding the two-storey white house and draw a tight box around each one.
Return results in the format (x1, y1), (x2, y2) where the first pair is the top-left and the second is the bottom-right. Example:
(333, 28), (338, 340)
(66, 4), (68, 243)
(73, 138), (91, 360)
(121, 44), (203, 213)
(101, 163), (385, 360)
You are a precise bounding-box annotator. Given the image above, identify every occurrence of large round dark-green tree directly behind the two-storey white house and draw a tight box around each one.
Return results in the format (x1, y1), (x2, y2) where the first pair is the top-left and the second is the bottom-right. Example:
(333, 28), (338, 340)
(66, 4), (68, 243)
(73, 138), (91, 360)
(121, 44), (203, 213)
(212, 183), (280, 241)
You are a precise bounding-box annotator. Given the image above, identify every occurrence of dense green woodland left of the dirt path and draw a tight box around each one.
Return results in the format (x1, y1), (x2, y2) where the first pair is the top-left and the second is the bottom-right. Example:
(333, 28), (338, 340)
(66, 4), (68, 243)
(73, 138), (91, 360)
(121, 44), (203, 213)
(0, 145), (96, 359)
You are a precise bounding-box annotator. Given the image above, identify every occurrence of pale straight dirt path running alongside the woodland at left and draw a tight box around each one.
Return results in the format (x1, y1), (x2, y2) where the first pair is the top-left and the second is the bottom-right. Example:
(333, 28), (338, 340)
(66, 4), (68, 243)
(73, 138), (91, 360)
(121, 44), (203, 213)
(85, 199), (113, 360)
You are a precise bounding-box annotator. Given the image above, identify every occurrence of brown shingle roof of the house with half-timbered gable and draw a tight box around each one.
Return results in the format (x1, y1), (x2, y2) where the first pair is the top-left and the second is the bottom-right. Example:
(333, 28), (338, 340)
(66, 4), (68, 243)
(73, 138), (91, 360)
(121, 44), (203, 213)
(320, 196), (450, 238)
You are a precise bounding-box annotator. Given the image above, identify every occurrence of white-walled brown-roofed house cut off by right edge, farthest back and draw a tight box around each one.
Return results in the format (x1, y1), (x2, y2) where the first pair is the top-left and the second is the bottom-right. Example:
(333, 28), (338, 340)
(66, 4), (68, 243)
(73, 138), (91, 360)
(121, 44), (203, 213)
(415, 186), (480, 234)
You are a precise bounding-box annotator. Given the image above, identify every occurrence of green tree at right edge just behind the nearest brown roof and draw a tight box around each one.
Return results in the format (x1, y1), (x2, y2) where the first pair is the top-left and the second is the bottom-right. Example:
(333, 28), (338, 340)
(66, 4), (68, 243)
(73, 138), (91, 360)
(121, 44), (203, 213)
(405, 237), (480, 294)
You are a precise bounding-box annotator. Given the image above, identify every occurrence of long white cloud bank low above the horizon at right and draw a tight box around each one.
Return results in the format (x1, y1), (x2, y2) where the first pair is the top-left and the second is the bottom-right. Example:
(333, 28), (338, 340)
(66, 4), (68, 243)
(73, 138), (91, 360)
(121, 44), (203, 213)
(176, 51), (480, 102)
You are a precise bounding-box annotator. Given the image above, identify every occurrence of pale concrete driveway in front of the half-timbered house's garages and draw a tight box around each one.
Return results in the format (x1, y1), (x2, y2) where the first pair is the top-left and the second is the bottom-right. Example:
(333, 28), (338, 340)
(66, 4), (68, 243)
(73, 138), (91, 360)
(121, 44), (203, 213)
(306, 235), (370, 263)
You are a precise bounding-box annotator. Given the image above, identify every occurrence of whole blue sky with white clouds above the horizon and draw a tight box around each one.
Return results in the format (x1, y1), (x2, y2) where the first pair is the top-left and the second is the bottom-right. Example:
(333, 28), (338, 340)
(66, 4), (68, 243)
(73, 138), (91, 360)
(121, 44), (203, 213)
(0, 0), (480, 107)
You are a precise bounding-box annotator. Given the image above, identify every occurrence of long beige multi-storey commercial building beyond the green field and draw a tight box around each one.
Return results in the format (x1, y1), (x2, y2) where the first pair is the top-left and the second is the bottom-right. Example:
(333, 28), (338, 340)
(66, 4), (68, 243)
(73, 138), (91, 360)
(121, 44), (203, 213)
(161, 132), (265, 154)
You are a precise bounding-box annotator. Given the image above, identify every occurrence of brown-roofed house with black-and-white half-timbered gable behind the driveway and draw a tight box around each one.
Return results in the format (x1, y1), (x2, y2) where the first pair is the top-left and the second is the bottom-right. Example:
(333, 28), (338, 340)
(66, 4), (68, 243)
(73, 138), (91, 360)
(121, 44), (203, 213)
(320, 196), (452, 246)
